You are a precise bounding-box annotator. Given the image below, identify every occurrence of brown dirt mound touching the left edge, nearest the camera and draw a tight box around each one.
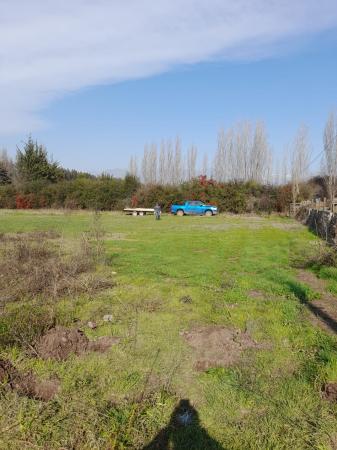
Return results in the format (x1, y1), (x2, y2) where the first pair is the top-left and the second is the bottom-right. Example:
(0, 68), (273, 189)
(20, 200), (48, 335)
(0, 359), (60, 401)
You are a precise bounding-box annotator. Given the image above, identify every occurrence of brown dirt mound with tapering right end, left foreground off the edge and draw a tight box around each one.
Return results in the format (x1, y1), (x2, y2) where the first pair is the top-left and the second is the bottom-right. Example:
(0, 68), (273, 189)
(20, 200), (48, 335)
(36, 326), (119, 361)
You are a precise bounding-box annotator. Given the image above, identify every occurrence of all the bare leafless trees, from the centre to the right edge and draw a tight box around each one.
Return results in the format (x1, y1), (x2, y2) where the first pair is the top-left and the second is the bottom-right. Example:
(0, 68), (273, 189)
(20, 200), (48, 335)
(129, 112), (337, 211)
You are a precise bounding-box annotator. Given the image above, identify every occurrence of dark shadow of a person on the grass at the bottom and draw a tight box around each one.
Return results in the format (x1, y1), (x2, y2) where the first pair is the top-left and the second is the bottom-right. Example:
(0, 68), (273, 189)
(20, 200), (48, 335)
(142, 399), (224, 450)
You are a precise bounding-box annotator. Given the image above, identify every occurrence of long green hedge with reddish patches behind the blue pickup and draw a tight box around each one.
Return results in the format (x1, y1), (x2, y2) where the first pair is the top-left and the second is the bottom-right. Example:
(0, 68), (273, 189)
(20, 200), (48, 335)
(0, 176), (291, 213)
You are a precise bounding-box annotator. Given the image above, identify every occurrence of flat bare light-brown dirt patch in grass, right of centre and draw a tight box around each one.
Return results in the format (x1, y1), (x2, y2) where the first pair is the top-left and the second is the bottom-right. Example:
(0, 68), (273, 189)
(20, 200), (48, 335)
(182, 326), (262, 371)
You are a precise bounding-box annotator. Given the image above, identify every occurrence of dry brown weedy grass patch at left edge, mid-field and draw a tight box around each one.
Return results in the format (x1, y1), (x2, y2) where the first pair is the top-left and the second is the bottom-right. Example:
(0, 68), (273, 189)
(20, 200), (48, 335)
(0, 232), (113, 303)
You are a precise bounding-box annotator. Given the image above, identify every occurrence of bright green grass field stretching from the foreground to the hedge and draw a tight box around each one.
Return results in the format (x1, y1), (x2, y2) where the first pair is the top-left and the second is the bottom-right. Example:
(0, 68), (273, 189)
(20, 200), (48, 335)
(0, 211), (337, 450)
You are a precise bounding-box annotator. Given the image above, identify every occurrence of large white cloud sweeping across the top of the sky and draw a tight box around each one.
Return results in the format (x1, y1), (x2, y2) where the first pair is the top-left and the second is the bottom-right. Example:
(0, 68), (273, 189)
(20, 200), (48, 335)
(0, 0), (337, 133)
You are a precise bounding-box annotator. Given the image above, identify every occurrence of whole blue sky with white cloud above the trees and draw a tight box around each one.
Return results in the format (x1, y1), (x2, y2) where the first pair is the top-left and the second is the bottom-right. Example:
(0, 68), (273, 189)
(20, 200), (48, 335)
(0, 0), (337, 172)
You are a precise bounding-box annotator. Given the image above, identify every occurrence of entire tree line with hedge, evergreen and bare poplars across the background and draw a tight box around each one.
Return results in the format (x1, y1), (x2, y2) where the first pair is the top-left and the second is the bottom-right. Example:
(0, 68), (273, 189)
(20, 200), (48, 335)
(0, 113), (337, 212)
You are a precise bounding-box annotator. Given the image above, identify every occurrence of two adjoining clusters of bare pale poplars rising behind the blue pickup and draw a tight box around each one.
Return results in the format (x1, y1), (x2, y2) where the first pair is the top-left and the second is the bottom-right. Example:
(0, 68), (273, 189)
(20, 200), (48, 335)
(129, 122), (273, 186)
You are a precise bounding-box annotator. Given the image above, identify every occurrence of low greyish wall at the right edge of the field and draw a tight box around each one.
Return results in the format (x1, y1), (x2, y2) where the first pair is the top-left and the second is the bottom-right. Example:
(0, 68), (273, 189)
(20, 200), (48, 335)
(296, 208), (337, 245)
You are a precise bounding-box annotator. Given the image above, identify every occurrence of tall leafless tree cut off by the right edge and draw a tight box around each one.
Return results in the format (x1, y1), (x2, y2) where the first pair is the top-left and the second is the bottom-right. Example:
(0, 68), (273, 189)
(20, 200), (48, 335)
(323, 112), (337, 208)
